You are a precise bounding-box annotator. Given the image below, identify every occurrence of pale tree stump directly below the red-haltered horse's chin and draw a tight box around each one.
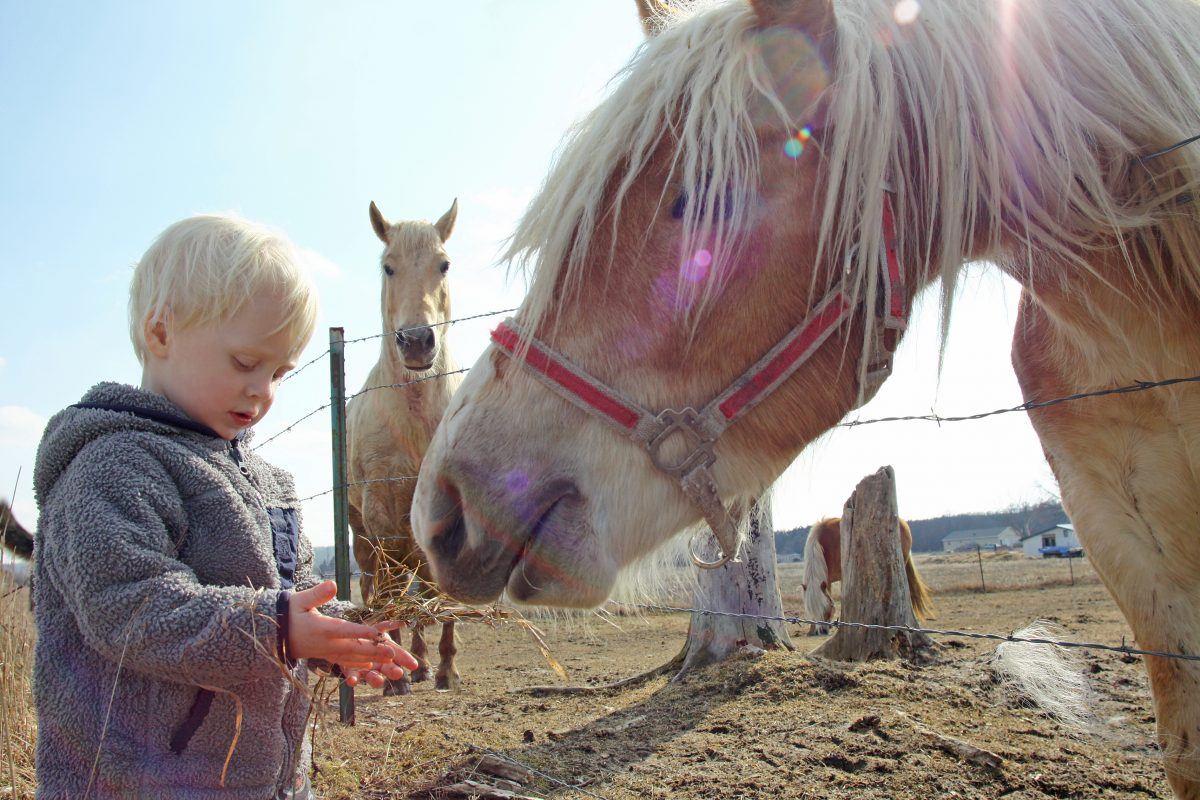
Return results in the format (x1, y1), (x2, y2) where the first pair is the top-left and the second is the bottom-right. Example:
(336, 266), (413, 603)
(672, 497), (794, 680)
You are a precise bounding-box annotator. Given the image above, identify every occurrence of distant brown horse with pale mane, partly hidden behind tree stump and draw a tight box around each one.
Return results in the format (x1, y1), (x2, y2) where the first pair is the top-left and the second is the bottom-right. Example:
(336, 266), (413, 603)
(802, 517), (934, 636)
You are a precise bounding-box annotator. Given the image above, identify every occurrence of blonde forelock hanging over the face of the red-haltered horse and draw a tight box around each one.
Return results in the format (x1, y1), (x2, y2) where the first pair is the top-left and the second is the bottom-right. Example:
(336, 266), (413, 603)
(505, 1), (762, 338)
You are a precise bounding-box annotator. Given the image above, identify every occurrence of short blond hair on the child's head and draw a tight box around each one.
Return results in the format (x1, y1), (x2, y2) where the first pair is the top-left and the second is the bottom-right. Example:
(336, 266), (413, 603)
(130, 213), (317, 363)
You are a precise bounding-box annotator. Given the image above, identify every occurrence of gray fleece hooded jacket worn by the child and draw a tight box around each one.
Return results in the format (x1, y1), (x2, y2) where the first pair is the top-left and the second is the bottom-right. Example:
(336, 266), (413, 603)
(34, 384), (343, 800)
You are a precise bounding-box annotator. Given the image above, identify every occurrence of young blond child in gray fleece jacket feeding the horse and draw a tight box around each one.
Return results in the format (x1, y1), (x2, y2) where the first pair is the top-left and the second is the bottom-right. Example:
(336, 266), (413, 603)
(34, 216), (416, 800)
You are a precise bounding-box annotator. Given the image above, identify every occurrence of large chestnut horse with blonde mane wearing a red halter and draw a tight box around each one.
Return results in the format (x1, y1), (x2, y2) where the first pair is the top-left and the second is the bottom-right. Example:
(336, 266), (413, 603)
(413, 0), (1200, 800)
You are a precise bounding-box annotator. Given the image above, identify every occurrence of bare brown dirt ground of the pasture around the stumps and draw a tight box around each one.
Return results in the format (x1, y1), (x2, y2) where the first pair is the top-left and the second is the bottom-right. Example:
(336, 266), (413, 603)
(316, 555), (1171, 800)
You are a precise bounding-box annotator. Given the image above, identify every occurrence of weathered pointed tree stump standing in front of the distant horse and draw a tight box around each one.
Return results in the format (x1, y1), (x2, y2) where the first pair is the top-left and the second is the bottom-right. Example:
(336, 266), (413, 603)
(812, 467), (936, 663)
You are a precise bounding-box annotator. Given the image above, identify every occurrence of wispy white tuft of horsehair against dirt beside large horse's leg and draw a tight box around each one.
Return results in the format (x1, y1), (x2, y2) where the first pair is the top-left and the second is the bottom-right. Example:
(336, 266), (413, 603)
(989, 620), (1103, 734)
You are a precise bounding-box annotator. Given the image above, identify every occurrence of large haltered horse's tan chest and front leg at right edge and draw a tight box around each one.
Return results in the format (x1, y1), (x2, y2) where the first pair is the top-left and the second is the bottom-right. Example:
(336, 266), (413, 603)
(1013, 294), (1200, 800)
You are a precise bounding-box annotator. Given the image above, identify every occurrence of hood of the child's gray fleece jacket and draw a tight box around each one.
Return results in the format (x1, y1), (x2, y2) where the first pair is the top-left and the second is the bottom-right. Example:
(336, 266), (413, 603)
(34, 383), (246, 506)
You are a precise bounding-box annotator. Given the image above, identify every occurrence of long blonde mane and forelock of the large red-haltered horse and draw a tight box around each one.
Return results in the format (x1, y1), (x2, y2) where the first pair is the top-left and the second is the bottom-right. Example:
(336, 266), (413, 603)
(506, 0), (1200, 376)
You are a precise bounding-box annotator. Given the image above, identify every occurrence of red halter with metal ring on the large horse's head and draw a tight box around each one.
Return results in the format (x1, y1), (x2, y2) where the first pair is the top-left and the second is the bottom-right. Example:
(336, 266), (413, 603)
(492, 194), (907, 569)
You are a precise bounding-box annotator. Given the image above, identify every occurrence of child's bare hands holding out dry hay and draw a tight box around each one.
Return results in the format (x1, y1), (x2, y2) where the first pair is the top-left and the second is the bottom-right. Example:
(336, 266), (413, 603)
(288, 581), (418, 685)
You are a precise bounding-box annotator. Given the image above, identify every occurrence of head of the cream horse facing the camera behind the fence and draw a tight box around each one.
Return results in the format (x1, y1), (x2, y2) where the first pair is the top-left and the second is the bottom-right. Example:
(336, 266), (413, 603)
(370, 200), (458, 372)
